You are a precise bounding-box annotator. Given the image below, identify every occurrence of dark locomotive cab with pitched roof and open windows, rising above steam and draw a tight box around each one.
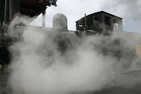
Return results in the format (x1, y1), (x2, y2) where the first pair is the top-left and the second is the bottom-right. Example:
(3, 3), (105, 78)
(76, 11), (123, 33)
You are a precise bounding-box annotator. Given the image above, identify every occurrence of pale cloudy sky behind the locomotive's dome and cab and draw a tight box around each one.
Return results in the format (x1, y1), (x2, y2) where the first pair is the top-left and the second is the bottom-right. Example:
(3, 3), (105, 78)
(32, 0), (141, 33)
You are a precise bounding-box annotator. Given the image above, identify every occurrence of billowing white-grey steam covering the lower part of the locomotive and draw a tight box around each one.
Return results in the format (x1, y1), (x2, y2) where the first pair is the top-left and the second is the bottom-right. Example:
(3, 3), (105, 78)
(8, 17), (141, 94)
